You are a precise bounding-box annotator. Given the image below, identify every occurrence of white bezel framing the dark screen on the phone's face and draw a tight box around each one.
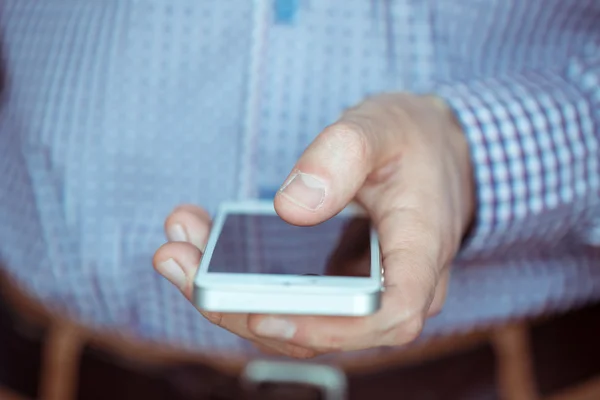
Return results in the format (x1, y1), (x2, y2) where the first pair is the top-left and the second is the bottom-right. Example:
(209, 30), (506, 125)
(194, 201), (382, 294)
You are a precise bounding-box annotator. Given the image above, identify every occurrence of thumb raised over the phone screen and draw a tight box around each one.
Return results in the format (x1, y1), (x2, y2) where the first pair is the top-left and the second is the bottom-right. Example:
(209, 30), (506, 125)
(275, 121), (384, 226)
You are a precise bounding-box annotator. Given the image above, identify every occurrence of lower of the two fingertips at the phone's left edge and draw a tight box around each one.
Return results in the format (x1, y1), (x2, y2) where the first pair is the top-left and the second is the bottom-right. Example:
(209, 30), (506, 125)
(152, 242), (202, 301)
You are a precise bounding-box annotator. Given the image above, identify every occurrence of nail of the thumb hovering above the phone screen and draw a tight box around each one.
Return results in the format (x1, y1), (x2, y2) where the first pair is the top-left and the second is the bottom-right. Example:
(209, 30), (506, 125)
(279, 171), (325, 211)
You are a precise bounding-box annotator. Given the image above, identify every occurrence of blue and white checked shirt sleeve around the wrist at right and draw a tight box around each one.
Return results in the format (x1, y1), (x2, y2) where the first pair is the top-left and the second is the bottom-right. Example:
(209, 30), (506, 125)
(438, 40), (600, 258)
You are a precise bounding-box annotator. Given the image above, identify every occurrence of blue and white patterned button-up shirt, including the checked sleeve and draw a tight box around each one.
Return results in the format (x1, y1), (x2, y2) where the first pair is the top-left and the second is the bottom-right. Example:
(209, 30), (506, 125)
(0, 0), (600, 352)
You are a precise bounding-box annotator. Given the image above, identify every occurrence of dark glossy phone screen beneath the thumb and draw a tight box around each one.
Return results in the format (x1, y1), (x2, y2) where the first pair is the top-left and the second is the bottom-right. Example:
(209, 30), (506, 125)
(208, 214), (371, 277)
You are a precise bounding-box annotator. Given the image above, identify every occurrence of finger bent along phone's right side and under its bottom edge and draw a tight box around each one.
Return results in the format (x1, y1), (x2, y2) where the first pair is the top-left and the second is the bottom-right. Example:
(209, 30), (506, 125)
(249, 205), (438, 351)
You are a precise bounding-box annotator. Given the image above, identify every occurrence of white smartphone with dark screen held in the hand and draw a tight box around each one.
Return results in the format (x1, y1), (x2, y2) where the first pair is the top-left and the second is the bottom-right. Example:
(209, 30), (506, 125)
(194, 201), (383, 316)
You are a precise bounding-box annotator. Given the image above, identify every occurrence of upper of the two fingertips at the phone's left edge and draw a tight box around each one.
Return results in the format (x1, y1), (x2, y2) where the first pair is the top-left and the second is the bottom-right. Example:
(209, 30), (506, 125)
(164, 204), (211, 251)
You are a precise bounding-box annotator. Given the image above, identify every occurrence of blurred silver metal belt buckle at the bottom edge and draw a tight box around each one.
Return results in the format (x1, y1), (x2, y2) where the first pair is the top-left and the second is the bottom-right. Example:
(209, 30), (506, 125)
(241, 360), (347, 400)
